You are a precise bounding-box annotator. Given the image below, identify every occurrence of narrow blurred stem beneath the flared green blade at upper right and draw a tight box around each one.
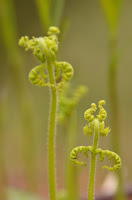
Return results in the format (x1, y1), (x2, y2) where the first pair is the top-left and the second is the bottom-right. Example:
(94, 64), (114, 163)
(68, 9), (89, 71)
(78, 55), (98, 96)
(108, 34), (125, 200)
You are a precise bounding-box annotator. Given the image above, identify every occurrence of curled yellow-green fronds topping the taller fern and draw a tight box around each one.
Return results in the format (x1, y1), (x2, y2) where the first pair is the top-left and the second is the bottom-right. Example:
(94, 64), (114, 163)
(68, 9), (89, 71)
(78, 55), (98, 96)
(19, 27), (73, 92)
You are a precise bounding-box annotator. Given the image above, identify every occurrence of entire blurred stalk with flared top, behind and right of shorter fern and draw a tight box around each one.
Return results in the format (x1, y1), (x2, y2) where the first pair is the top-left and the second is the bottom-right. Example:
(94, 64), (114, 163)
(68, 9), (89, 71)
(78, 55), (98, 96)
(98, 0), (125, 200)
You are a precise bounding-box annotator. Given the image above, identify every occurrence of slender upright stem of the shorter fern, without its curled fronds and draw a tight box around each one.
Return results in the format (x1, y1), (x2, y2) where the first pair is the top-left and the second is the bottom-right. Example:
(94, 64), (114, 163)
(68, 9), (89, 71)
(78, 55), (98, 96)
(88, 119), (99, 200)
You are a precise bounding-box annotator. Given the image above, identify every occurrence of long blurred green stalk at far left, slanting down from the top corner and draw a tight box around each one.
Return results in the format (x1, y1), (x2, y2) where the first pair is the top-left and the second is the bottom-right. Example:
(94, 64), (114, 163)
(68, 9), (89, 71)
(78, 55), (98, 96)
(0, 0), (37, 191)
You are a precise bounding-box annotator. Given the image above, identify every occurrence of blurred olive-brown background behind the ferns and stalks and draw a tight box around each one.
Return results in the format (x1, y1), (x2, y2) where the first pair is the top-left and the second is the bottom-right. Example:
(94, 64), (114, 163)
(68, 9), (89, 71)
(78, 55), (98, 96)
(0, 0), (132, 196)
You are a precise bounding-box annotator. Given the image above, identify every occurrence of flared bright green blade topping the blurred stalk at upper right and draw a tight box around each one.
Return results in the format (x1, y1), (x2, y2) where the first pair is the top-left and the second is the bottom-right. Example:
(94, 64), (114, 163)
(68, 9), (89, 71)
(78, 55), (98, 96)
(100, 0), (123, 32)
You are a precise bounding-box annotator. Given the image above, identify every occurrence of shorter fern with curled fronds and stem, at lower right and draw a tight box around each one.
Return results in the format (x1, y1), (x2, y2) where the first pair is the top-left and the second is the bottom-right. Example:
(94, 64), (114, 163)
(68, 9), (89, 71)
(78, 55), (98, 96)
(70, 100), (121, 200)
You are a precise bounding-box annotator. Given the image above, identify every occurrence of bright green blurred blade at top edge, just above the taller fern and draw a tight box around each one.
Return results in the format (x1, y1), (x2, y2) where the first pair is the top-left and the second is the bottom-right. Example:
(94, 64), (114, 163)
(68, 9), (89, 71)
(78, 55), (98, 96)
(35, 0), (51, 32)
